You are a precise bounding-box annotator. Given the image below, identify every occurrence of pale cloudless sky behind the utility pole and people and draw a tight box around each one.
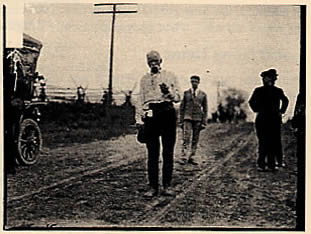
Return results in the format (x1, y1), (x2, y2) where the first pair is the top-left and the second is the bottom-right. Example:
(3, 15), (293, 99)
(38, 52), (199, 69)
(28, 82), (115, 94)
(24, 1), (300, 117)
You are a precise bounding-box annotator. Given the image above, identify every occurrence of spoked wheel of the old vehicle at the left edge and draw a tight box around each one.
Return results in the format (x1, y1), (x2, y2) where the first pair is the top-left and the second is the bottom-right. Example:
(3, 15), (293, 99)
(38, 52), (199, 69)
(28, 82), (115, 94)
(17, 119), (42, 165)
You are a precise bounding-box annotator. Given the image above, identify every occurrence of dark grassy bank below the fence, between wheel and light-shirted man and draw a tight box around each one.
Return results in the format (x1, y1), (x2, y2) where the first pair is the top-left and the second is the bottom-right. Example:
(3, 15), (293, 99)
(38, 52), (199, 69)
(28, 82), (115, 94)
(40, 103), (135, 148)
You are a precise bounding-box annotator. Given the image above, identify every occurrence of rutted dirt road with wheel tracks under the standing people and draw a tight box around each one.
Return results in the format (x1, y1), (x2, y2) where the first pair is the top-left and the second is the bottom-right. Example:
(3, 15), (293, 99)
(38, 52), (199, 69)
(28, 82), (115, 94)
(6, 124), (297, 229)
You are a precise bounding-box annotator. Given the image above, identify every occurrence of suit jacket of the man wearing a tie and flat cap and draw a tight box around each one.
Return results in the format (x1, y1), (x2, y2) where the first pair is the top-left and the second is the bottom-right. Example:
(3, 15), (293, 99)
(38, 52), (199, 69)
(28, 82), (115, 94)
(179, 89), (207, 124)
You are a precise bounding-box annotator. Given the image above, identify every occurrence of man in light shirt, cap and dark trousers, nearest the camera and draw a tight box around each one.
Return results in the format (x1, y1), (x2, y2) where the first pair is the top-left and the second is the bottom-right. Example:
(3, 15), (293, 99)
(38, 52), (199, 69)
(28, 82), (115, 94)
(136, 51), (180, 197)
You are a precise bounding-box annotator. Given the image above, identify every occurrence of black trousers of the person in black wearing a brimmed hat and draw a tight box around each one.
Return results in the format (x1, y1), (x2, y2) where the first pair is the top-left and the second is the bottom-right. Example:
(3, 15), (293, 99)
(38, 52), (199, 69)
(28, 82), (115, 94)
(255, 114), (283, 169)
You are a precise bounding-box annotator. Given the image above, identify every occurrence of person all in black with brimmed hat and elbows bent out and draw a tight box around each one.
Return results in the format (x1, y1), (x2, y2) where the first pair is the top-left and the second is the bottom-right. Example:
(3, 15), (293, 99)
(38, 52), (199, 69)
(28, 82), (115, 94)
(249, 69), (288, 171)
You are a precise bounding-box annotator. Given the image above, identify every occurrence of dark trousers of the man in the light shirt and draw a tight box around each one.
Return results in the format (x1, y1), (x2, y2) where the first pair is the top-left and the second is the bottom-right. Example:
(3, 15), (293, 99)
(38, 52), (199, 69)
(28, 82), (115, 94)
(144, 103), (176, 190)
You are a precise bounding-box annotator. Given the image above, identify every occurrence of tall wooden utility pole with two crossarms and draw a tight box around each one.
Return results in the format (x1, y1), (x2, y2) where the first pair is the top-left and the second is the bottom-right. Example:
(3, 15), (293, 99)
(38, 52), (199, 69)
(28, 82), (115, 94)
(94, 3), (137, 106)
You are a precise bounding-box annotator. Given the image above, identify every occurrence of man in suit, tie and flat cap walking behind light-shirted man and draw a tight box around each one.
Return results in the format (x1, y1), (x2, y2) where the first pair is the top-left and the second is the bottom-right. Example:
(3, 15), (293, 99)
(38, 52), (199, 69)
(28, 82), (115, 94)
(179, 76), (207, 165)
